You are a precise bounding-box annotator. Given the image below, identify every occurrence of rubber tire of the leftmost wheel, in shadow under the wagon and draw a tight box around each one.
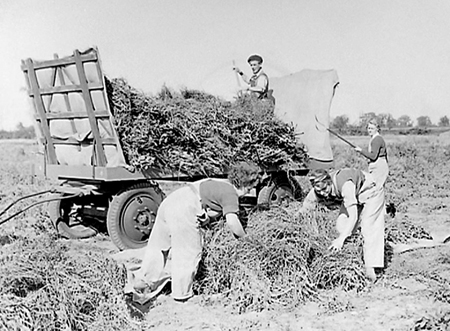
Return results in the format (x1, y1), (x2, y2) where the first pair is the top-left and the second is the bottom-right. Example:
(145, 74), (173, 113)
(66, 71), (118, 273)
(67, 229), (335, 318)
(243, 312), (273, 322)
(47, 194), (98, 239)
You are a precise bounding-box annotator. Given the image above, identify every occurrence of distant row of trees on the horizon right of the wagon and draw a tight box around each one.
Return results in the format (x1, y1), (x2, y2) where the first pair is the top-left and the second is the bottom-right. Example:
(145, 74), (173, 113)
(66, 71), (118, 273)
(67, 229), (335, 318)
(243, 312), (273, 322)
(330, 112), (450, 134)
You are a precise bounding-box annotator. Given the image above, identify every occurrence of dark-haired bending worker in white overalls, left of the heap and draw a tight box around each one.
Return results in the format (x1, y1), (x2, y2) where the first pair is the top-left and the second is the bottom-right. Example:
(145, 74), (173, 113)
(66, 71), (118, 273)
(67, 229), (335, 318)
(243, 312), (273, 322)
(125, 162), (260, 304)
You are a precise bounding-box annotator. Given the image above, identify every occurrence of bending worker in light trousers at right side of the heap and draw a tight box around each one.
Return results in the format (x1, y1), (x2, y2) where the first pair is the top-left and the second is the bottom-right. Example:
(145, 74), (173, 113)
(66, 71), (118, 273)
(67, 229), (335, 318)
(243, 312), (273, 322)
(299, 168), (385, 282)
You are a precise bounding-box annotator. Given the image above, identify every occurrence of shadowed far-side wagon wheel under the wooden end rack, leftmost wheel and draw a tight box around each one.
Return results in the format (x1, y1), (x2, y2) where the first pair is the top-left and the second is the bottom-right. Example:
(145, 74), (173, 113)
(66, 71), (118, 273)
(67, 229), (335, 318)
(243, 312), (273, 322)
(47, 194), (98, 239)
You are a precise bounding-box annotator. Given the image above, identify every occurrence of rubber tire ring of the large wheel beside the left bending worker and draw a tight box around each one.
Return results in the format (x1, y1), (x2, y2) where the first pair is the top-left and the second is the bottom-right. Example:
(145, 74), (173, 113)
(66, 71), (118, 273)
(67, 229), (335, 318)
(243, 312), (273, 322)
(106, 183), (164, 250)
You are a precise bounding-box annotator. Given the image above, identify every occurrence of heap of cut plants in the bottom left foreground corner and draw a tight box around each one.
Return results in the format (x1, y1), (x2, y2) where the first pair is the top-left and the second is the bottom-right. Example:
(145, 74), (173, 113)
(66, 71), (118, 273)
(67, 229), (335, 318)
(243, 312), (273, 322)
(0, 234), (142, 331)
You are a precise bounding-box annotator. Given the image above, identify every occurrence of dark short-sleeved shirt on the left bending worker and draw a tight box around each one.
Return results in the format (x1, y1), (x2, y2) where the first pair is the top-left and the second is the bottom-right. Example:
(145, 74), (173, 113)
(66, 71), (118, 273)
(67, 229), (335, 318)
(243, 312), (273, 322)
(199, 179), (239, 216)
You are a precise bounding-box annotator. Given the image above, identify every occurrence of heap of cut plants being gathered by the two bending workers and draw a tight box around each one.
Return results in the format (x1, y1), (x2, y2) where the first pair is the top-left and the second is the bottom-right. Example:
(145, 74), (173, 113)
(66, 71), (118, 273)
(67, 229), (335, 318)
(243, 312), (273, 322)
(196, 205), (432, 312)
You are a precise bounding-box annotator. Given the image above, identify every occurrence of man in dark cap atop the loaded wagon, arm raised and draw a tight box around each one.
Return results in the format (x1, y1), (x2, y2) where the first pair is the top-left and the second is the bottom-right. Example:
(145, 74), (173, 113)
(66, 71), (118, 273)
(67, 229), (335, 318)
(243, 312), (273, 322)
(233, 54), (269, 99)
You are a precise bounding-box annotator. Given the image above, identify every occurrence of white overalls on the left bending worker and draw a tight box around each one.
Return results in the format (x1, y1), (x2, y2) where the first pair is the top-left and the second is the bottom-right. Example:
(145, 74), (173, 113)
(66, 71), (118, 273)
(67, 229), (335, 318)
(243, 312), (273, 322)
(126, 179), (208, 302)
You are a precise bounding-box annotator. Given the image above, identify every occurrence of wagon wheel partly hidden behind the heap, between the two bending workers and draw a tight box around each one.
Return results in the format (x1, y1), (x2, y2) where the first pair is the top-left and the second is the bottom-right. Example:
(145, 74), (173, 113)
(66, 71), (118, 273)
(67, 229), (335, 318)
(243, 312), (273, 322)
(258, 174), (303, 207)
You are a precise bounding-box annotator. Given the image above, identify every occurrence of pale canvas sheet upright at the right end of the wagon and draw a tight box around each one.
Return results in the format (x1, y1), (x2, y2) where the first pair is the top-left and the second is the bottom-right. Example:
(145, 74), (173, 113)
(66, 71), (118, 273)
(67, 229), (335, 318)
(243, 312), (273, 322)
(270, 69), (339, 161)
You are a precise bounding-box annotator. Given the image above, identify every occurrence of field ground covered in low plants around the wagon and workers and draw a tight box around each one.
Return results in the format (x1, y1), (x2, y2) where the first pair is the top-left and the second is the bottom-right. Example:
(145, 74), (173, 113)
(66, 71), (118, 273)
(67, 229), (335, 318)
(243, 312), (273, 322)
(0, 134), (450, 331)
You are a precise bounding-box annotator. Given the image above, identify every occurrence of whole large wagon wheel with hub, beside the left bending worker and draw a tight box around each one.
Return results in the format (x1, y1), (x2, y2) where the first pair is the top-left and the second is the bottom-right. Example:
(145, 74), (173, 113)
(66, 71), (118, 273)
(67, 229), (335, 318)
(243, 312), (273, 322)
(106, 183), (164, 250)
